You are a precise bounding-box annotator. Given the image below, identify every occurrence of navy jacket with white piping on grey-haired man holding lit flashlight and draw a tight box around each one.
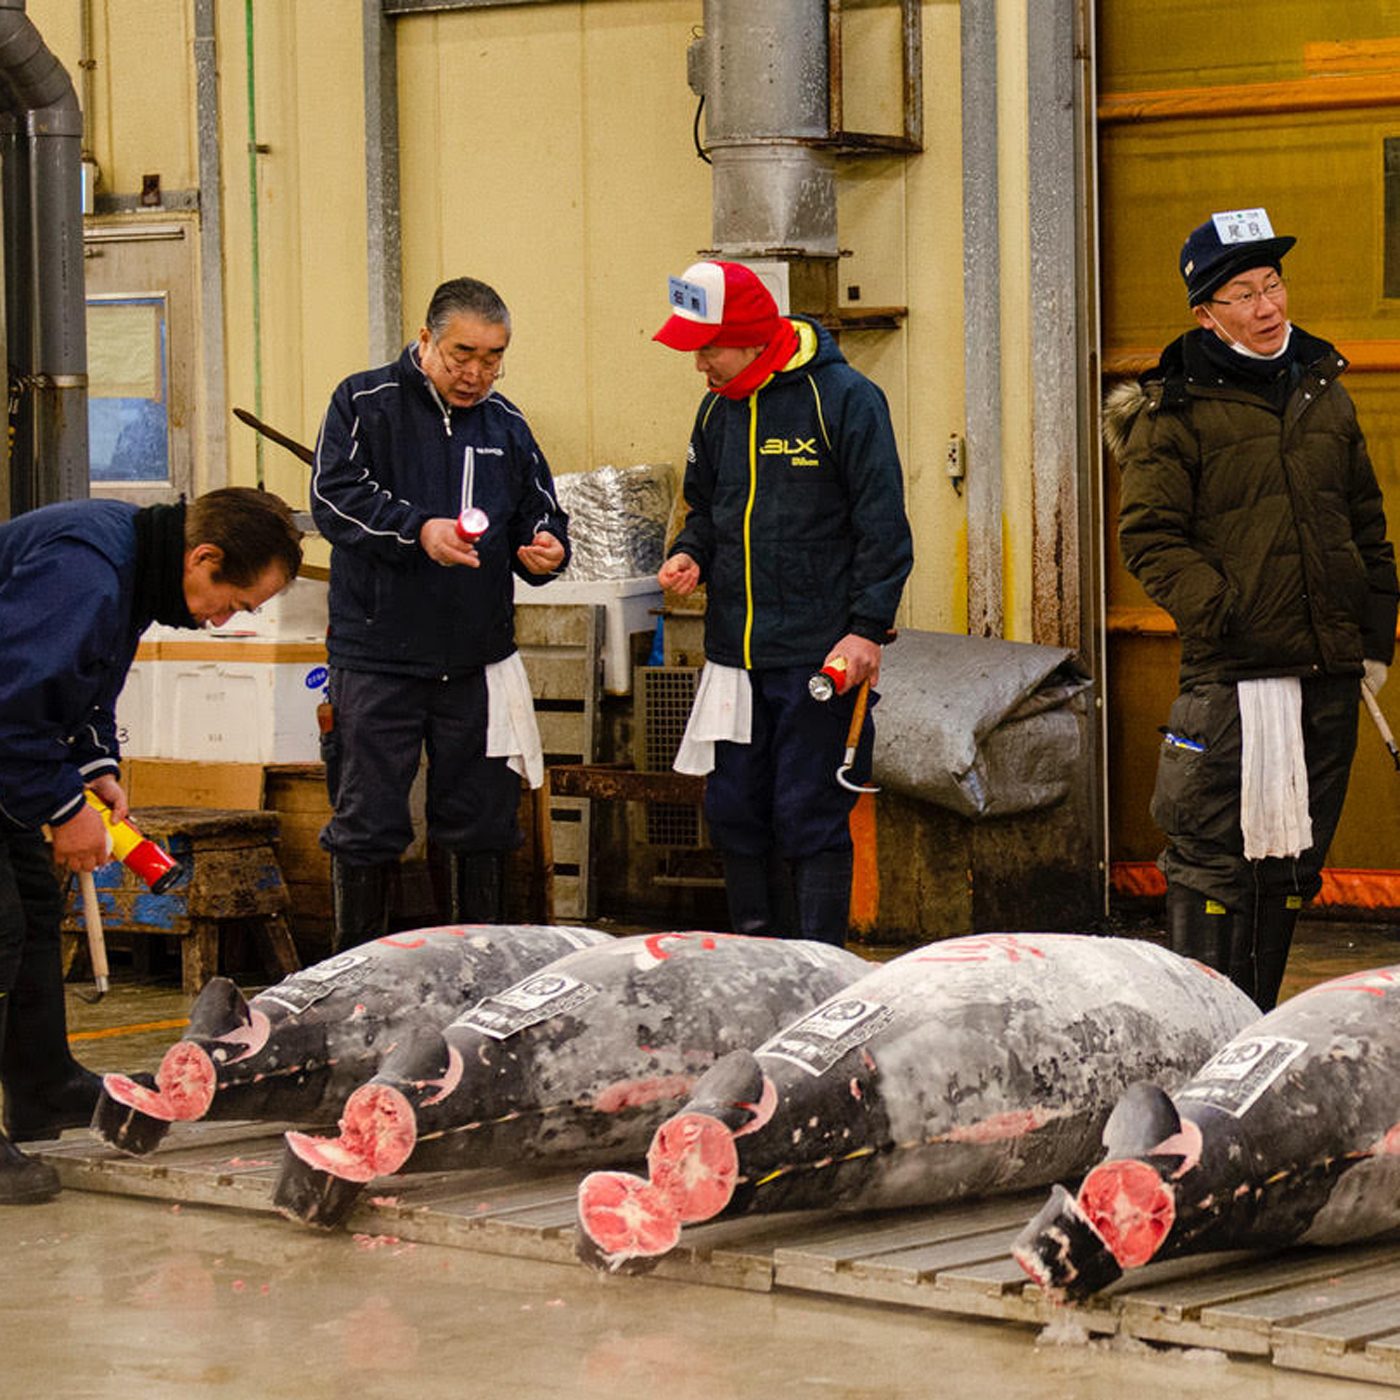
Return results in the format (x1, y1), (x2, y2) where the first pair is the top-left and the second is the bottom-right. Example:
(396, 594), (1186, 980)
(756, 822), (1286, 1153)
(311, 343), (568, 678)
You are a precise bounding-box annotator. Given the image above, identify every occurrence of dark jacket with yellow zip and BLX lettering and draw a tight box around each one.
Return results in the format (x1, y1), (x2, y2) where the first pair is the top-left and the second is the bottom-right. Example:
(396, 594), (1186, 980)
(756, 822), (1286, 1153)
(669, 316), (914, 669)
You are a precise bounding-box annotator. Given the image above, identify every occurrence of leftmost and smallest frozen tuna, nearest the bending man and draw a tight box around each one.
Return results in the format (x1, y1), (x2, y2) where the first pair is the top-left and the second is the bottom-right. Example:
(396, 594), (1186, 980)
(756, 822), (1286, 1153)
(92, 924), (609, 1155)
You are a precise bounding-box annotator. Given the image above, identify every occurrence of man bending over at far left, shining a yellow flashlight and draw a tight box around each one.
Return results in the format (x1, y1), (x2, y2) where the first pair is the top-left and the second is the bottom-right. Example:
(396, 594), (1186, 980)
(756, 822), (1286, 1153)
(0, 487), (301, 1204)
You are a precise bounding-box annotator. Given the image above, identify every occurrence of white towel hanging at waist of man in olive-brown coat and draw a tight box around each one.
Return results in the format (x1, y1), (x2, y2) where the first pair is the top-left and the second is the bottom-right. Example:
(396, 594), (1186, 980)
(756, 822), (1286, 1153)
(1236, 676), (1312, 861)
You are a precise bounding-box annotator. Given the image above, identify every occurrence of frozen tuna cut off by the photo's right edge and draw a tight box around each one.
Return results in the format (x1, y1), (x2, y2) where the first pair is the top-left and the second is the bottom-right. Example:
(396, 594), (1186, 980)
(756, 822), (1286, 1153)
(1014, 965), (1400, 1299)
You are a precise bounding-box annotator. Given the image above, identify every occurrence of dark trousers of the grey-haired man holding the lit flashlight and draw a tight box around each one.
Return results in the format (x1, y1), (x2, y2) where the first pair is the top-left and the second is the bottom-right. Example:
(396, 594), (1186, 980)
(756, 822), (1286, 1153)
(321, 666), (524, 865)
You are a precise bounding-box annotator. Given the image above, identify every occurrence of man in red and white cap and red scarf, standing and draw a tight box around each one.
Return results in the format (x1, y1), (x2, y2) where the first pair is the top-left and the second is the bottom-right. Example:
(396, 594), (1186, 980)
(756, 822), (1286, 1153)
(654, 260), (913, 944)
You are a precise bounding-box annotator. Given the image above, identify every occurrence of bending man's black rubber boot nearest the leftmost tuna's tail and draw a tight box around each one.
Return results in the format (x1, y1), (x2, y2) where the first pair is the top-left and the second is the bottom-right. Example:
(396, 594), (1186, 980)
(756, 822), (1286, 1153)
(0, 938), (102, 1142)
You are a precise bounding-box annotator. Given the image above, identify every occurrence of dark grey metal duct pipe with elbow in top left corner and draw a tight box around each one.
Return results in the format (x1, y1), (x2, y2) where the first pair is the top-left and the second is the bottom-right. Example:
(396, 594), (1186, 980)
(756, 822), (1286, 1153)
(0, 0), (88, 514)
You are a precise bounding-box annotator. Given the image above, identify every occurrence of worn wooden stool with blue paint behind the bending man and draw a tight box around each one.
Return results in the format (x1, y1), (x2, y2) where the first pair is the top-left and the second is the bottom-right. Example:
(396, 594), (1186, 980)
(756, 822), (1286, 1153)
(63, 806), (301, 997)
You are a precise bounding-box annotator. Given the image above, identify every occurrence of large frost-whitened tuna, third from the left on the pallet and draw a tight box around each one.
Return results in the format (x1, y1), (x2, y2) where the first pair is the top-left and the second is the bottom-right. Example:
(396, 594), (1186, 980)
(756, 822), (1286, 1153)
(578, 934), (1259, 1270)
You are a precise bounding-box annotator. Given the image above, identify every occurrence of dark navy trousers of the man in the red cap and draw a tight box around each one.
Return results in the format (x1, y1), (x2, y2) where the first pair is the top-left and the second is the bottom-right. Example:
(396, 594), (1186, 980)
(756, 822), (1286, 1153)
(704, 666), (876, 860)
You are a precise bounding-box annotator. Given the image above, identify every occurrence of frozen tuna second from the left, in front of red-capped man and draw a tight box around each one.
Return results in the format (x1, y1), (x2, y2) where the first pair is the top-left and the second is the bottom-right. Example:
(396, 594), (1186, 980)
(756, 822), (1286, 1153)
(273, 932), (869, 1226)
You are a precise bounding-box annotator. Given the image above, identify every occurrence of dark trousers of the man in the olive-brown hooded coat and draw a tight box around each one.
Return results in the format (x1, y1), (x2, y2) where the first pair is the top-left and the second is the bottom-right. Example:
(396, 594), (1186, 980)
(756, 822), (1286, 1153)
(1152, 676), (1361, 914)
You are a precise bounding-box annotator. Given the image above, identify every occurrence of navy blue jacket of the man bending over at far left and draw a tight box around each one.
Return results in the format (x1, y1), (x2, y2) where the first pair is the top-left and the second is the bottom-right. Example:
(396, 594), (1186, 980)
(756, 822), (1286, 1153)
(0, 501), (150, 830)
